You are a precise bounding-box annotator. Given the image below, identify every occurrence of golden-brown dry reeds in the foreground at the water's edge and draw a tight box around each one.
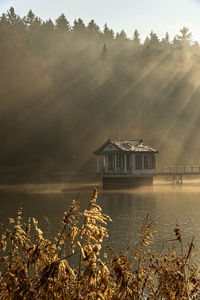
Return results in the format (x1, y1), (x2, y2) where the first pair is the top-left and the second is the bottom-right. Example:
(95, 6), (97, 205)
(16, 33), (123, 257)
(0, 189), (200, 300)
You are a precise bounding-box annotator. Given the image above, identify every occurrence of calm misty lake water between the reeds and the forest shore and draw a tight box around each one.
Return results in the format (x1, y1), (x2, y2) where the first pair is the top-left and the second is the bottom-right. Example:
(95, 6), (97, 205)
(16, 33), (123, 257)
(0, 179), (200, 255)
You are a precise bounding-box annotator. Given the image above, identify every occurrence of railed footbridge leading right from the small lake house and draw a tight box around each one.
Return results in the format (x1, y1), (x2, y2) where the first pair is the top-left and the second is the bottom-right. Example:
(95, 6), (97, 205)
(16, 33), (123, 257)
(154, 166), (200, 176)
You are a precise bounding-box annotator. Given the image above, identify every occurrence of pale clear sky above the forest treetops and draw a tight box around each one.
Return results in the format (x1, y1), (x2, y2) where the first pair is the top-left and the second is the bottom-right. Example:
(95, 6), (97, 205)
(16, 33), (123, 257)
(0, 0), (200, 42)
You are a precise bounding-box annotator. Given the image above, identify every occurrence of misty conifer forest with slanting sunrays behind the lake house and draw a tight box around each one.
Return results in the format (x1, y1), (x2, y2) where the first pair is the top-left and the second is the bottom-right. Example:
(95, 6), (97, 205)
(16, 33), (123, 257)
(0, 8), (200, 175)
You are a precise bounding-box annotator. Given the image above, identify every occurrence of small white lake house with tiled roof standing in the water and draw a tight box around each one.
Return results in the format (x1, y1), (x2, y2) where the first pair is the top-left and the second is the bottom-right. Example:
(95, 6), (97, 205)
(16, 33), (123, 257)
(93, 138), (158, 189)
